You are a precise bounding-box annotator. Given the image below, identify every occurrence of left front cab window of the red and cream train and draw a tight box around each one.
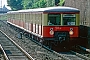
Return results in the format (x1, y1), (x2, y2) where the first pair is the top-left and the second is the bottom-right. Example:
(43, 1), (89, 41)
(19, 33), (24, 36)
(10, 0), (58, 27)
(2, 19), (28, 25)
(48, 14), (61, 25)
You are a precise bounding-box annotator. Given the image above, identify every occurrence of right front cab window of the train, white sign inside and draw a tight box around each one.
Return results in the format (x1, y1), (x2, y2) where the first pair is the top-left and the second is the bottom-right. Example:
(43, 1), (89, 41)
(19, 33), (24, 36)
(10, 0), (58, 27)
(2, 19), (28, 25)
(63, 14), (76, 25)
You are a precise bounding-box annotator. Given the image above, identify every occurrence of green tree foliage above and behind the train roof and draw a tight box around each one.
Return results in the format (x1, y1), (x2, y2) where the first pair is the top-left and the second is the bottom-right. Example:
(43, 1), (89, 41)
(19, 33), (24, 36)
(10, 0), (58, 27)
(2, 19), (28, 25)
(7, 0), (65, 10)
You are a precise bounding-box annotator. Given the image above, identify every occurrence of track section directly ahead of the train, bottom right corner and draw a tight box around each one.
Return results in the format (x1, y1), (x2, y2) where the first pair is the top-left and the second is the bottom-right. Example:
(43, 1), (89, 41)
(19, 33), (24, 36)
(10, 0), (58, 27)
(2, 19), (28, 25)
(60, 46), (90, 60)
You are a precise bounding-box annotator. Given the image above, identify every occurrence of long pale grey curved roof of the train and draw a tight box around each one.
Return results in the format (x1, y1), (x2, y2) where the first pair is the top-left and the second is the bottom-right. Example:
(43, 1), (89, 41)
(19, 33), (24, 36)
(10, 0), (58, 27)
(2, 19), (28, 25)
(8, 6), (80, 13)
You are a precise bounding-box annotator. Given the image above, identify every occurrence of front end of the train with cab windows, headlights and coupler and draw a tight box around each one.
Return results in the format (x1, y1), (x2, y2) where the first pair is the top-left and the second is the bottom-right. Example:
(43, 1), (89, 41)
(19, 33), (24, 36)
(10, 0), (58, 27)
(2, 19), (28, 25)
(42, 8), (87, 50)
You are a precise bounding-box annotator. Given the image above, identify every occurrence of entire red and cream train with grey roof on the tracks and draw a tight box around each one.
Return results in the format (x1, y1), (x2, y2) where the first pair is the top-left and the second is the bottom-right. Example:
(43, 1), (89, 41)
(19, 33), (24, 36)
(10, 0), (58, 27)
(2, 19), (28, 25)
(7, 6), (88, 51)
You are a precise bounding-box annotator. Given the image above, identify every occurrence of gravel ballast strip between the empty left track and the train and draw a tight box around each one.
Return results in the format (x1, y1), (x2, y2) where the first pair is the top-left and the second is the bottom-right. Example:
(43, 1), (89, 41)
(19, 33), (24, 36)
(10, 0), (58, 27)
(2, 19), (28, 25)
(1, 22), (61, 60)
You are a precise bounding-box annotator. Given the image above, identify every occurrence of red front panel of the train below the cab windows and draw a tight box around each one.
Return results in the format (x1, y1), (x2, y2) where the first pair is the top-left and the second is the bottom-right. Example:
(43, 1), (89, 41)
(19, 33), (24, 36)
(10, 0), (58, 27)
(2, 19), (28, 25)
(43, 26), (79, 37)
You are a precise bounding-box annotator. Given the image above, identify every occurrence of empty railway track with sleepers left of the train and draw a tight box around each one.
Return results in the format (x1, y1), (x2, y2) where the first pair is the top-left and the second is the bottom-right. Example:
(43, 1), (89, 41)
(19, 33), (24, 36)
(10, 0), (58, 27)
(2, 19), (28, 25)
(0, 30), (34, 60)
